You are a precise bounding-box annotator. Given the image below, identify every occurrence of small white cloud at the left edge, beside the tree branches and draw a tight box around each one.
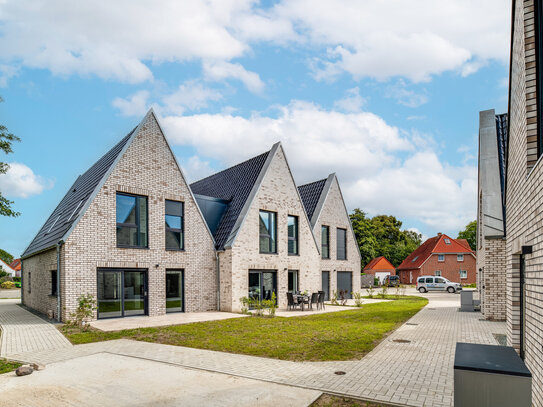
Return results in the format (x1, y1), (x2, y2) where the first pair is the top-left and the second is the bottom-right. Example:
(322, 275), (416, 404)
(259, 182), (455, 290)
(0, 162), (53, 198)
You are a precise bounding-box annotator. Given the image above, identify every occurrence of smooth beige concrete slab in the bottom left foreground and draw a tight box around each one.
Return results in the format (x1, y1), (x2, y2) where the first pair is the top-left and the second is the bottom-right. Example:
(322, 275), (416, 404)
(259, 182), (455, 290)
(0, 353), (321, 407)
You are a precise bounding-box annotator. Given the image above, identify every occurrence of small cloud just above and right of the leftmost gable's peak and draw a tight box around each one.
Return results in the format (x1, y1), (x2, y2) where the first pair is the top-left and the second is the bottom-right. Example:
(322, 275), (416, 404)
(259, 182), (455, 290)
(162, 81), (222, 114)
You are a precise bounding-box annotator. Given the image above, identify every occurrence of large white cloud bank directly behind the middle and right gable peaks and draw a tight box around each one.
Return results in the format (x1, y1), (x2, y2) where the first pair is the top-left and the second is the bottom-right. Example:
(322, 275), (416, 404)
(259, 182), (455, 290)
(162, 101), (477, 231)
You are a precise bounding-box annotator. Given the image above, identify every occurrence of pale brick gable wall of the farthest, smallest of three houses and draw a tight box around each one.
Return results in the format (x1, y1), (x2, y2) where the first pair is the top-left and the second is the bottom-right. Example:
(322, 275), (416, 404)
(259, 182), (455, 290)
(313, 178), (361, 295)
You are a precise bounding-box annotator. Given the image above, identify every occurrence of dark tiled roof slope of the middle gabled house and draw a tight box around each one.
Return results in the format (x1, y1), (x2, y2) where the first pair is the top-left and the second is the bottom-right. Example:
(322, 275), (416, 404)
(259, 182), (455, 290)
(190, 145), (277, 250)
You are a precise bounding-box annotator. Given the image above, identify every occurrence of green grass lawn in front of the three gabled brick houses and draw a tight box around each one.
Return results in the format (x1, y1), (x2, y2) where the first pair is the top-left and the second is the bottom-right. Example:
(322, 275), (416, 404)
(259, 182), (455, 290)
(61, 296), (428, 361)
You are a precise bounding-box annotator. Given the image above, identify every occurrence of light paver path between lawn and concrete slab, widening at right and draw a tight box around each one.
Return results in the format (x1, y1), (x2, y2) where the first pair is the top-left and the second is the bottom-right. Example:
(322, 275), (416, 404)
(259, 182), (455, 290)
(3, 294), (505, 406)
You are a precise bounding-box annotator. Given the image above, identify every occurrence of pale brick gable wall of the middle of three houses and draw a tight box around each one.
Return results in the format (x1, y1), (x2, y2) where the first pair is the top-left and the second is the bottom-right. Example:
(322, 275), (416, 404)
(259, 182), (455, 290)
(221, 148), (321, 311)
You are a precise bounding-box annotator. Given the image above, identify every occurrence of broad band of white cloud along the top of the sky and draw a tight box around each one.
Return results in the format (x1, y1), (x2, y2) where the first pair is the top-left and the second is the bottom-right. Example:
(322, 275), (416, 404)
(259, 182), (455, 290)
(0, 0), (510, 85)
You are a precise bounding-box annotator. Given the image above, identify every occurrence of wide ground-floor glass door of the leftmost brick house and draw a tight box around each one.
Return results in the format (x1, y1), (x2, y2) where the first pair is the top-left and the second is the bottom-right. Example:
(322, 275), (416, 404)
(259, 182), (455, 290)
(98, 269), (147, 318)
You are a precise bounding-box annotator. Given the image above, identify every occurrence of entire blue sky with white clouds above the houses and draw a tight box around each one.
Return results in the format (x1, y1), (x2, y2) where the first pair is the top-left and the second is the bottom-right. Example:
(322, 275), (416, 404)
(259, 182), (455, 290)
(0, 0), (510, 255)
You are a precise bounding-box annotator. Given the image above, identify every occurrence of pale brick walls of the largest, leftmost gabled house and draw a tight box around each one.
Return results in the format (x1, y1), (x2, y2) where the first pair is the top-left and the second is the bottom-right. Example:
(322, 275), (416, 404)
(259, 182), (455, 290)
(23, 113), (217, 320)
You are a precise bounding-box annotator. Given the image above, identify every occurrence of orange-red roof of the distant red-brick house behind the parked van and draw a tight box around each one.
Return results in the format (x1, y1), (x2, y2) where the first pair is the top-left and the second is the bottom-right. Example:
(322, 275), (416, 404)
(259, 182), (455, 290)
(398, 234), (473, 270)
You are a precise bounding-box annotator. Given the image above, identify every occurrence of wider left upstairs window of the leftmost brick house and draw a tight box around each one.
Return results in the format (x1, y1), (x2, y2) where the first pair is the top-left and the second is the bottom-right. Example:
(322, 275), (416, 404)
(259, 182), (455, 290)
(117, 193), (148, 247)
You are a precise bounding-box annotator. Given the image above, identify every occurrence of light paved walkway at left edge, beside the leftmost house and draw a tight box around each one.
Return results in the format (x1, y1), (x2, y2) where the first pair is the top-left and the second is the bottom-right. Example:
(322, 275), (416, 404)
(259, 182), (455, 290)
(0, 300), (73, 357)
